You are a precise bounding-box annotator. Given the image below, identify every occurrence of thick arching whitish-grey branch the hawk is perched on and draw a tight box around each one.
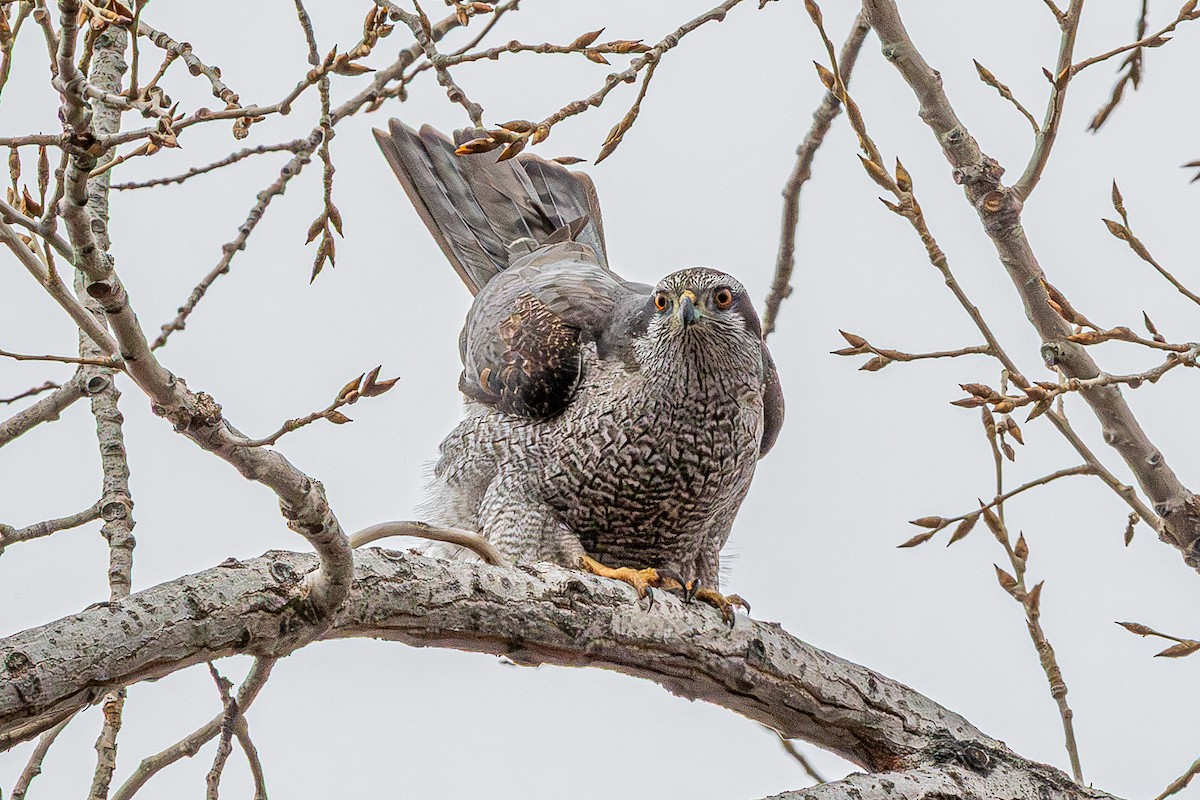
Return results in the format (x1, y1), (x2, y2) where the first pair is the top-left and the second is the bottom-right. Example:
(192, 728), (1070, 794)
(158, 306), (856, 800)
(0, 551), (1099, 796)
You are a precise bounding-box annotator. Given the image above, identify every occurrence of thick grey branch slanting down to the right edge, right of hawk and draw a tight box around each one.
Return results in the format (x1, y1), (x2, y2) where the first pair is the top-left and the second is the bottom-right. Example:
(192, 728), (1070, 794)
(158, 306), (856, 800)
(863, 0), (1200, 567)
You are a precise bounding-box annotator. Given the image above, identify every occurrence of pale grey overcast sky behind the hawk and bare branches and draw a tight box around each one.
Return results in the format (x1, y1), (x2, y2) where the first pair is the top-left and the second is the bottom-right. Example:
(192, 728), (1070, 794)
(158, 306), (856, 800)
(0, 0), (1200, 800)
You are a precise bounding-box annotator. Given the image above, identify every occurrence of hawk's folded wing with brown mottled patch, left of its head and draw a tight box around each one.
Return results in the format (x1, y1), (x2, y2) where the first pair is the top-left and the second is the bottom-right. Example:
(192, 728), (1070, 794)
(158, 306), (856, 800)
(458, 241), (629, 419)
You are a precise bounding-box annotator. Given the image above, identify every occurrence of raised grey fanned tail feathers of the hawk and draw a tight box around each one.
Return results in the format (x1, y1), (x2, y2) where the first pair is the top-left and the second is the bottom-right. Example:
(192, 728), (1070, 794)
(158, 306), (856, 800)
(374, 120), (608, 294)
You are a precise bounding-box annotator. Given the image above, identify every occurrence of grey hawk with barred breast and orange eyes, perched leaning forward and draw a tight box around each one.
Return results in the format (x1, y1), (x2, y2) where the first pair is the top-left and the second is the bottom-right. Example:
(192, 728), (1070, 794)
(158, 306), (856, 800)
(374, 120), (784, 622)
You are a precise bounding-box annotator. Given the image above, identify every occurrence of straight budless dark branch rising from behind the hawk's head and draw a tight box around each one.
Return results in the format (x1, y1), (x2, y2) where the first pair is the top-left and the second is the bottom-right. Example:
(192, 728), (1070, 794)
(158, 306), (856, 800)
(762, 12), (871, 337)
